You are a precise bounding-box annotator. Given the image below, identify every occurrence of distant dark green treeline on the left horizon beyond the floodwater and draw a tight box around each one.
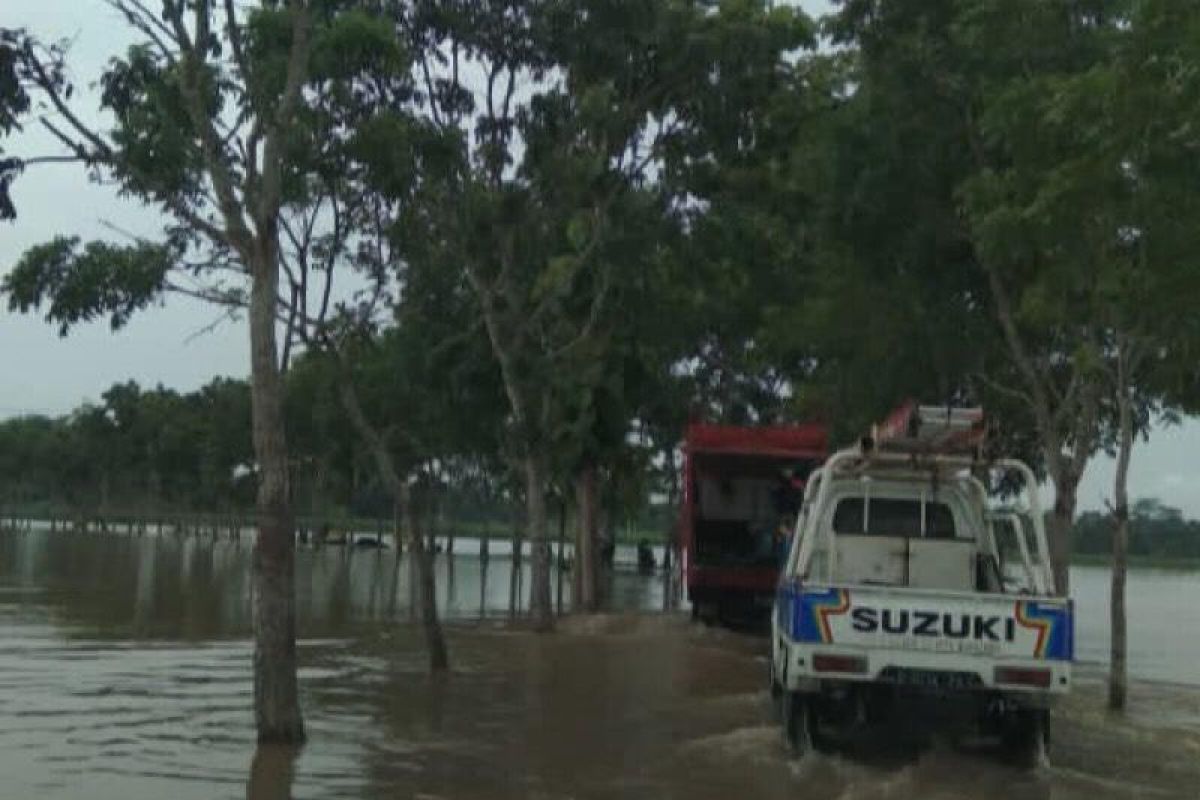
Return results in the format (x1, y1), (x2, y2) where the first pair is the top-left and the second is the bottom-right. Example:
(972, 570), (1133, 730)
(0, 379), (673, 540)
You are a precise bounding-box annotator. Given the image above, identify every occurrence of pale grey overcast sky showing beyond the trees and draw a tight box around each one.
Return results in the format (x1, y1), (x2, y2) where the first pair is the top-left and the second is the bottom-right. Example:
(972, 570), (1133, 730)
(0, 0), (1200, 517)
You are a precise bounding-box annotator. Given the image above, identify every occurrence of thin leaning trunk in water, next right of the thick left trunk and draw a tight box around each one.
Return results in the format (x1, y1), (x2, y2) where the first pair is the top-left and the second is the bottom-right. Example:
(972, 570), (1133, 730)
(335, 371), (450, 672)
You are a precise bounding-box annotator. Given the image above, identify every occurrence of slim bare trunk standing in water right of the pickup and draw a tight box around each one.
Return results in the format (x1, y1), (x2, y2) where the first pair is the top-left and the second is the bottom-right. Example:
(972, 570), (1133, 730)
(1109, 353), (1133, 711)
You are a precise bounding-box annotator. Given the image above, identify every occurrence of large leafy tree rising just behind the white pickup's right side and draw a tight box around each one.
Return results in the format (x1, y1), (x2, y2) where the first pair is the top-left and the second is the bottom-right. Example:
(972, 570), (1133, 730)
(816, 0), (1142, 593)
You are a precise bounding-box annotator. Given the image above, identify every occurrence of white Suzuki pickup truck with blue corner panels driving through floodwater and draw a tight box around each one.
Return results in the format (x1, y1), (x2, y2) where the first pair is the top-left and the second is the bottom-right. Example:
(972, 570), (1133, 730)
(770, 405), (1074, 763)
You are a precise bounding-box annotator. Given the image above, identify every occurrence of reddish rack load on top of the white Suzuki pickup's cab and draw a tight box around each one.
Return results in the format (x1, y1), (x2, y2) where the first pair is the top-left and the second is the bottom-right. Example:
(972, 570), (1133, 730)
(860, 401), (986, 458)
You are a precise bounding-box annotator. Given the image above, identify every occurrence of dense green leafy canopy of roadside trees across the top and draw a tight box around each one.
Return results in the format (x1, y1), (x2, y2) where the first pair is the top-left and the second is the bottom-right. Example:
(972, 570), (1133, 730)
(9, 0), (1200, 551)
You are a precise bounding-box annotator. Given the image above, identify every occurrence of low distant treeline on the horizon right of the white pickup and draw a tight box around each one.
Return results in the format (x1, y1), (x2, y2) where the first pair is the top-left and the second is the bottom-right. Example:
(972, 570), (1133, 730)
(1074, 499), (1200, 561)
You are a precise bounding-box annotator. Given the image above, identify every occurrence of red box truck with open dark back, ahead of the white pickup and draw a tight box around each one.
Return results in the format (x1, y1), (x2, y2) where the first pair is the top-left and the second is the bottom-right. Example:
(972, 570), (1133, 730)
(679, 422), (829, 622)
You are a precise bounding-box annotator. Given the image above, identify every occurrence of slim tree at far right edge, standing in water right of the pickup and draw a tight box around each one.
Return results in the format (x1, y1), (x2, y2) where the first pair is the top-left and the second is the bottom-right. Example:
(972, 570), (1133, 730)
(1084, 0), (1200, 710)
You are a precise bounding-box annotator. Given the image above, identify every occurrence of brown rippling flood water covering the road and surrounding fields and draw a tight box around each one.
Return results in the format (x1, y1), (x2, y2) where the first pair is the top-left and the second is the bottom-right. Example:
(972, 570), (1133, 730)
(0, 531), (1200, 800)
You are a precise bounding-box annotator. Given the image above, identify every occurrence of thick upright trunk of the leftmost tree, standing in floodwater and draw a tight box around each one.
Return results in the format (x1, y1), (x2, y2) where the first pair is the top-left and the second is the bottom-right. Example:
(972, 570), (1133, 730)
(250, 240), (305, 742)
